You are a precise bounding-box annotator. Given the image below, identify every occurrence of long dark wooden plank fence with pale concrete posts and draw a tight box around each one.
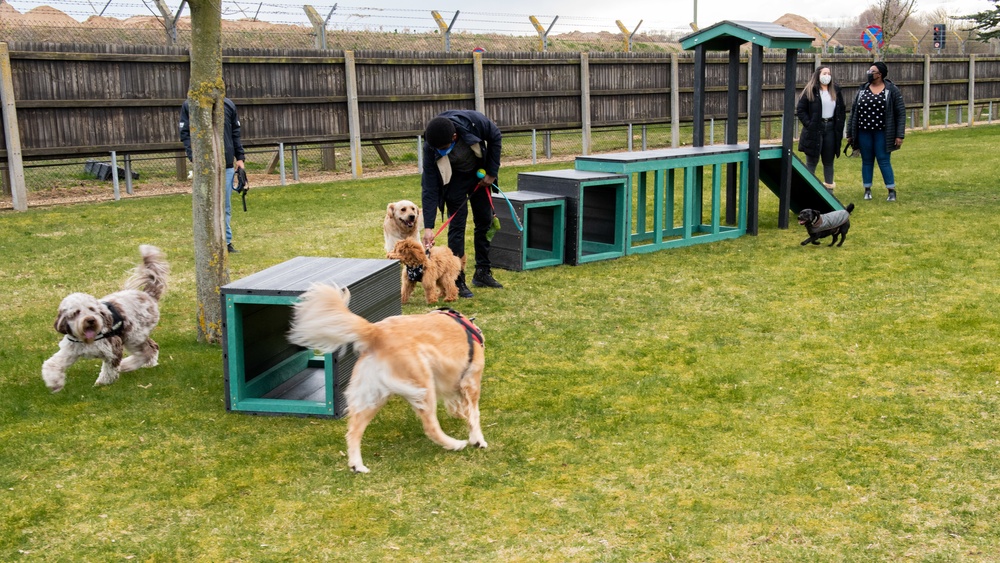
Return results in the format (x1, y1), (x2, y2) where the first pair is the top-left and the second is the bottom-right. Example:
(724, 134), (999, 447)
(0, 43), (1000, 209)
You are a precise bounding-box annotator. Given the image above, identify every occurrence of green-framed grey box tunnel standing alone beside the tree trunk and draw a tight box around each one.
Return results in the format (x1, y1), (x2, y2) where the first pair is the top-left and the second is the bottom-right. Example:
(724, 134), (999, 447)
(220, 256), (402, 418)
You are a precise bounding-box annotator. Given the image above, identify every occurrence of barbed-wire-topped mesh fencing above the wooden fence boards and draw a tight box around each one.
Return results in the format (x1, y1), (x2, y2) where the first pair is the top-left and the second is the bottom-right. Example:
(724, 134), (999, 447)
(0, 0), (1000, 54)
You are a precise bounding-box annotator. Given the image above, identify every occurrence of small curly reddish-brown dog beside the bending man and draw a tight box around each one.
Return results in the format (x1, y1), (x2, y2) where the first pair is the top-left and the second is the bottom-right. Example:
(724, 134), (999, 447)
(389, 239), (465, 305)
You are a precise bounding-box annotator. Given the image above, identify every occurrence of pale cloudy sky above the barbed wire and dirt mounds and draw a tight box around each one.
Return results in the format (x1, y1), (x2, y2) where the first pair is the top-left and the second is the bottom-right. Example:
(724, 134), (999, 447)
(0, 0), (995, 34)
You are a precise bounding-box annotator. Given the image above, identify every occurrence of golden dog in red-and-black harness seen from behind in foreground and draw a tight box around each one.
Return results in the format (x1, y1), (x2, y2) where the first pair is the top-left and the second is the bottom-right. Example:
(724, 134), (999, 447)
(288, 284), (487, 473)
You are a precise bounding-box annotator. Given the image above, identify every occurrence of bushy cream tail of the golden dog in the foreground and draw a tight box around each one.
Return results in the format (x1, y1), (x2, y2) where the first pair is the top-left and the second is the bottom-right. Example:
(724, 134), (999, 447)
(288, 284), (377, 360)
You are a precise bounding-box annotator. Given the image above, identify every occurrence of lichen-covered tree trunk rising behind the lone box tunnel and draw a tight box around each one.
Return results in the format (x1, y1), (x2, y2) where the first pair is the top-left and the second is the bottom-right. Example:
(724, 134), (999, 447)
(188, 0), (229, 342)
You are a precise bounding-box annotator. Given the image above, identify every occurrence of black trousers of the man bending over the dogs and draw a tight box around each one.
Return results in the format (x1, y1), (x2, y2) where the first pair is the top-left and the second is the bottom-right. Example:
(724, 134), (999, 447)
(444, 171), (493, 268)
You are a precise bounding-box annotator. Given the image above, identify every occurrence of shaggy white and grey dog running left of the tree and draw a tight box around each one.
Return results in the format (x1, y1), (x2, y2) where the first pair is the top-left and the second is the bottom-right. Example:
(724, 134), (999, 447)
(42, 244), (169, 393)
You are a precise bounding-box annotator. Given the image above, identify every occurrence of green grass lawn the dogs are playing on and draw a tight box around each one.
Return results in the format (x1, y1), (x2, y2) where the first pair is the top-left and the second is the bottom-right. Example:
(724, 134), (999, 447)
(0, 126), (1000, 562)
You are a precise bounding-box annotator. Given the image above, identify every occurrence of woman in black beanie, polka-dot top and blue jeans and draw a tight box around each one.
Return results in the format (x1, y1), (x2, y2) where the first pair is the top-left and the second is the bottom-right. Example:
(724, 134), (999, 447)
(847, 61), (906, 201)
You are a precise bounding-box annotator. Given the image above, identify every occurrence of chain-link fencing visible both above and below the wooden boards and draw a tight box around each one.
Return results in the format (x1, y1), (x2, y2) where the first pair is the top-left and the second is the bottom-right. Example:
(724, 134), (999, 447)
(0, 1), (998, 208)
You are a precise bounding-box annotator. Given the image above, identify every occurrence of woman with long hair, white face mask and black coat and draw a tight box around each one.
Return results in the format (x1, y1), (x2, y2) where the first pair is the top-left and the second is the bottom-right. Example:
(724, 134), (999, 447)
(795, 66), (847, 193)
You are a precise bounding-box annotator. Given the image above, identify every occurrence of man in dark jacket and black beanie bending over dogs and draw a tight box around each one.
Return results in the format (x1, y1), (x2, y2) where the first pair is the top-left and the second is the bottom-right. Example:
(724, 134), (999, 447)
(420, 110), (503, 298)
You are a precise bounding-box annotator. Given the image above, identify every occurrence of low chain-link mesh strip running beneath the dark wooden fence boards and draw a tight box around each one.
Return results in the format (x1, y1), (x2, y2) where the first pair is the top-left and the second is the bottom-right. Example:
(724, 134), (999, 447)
(0, 102), (1000, 209)
